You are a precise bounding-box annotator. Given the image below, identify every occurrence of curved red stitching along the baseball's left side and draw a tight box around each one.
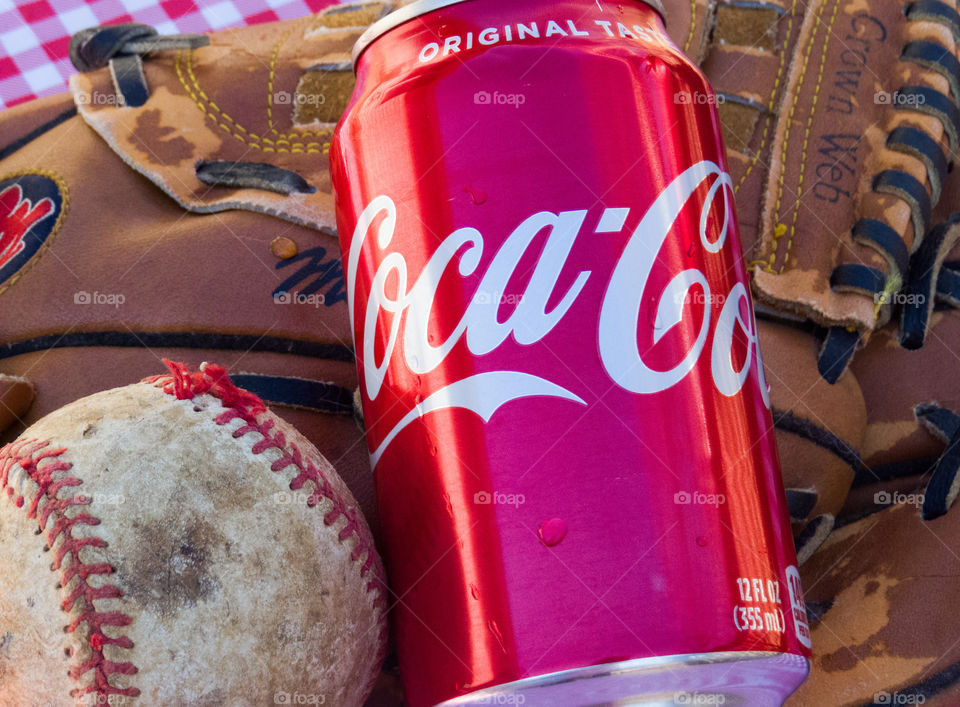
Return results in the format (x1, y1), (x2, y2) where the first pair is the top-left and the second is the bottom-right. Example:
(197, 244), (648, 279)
(0, 439), (140, 704)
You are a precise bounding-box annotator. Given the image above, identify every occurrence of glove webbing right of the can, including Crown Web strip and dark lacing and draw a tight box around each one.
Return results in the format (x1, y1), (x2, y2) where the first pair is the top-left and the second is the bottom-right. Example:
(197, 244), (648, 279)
(704, 0), (960, 381)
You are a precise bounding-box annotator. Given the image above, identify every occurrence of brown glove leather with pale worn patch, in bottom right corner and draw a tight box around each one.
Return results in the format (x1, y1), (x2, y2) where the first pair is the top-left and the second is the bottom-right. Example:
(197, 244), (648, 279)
(787, 504), (960, 707)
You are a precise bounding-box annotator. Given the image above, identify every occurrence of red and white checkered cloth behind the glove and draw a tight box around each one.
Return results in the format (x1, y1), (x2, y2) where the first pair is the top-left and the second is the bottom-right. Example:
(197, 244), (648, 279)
(0, 0), (334, 109)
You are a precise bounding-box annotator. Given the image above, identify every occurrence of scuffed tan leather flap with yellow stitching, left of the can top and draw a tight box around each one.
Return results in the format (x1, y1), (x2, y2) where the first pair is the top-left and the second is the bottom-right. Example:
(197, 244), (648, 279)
(71, 3), (391, 229)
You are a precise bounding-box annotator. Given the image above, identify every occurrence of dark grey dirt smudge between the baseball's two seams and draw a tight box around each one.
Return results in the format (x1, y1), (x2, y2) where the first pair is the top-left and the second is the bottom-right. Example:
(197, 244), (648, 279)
(116, 519), (227, 616)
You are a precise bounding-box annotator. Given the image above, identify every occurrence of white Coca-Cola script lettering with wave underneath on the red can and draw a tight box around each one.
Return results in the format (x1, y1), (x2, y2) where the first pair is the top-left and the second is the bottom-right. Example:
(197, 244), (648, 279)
(347, 160), (769, 466)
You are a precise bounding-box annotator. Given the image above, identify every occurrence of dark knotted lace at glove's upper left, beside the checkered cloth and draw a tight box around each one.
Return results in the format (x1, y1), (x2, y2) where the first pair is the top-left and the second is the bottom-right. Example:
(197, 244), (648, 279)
(70, 22), (210, 108)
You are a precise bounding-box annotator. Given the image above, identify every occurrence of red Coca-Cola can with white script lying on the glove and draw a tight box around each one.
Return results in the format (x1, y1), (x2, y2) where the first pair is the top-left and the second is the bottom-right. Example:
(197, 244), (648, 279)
(331, 0), (810, 707)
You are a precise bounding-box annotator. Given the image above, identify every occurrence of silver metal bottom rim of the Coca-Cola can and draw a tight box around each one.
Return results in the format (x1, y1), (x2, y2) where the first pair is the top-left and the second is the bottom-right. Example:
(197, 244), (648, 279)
(437, 651), (810, 707)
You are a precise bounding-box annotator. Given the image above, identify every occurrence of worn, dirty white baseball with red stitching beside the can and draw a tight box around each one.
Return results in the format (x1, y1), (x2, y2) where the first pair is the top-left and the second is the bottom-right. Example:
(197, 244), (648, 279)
(0, 364), (386, 706)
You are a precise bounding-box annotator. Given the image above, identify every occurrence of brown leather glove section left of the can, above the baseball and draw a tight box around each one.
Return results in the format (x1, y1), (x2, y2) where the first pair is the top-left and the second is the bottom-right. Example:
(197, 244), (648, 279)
(0, 3), (398, 527)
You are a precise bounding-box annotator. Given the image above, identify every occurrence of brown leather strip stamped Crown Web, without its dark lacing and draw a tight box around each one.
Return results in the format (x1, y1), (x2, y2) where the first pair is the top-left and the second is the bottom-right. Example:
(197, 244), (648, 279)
(754, 0), (957, 333)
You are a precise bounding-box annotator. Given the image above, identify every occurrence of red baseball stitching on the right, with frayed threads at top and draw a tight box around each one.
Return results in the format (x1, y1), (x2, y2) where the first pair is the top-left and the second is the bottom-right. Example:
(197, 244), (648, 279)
(143, 359), (387, 612)
